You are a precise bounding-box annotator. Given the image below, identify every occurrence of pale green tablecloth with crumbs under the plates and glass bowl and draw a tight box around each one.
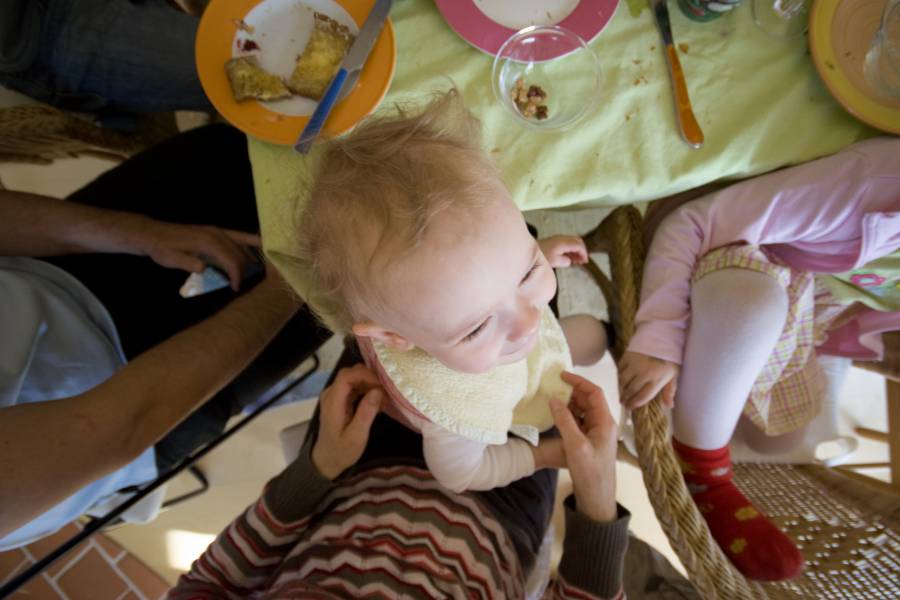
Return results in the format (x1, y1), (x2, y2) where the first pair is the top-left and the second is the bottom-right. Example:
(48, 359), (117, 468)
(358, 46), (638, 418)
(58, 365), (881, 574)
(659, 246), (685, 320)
(249, 0), (872, 292)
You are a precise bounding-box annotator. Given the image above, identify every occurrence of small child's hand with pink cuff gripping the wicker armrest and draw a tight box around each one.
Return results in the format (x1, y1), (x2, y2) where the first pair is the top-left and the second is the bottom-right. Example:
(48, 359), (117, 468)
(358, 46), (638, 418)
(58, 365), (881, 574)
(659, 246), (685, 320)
(619, 352), (681, 408)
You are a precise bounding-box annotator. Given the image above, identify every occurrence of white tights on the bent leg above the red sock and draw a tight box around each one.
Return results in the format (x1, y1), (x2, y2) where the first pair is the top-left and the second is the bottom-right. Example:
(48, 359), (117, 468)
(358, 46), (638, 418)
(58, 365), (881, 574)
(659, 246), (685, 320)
(672, 268), (788, 450)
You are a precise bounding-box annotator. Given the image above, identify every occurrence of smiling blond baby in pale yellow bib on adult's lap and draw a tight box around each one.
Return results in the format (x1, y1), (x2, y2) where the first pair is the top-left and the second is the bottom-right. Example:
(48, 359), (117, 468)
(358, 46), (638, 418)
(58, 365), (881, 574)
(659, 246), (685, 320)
(296, 91), (607, 491)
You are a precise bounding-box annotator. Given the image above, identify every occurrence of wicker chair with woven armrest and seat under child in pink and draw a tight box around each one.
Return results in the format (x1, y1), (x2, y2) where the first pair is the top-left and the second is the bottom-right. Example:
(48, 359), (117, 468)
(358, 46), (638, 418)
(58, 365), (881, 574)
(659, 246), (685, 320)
(586, 206), (900, 600)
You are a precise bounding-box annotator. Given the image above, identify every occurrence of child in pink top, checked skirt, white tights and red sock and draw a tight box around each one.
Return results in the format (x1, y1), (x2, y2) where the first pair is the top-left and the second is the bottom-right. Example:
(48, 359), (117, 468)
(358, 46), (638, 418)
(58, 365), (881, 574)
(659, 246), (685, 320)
(619, 139), (900, 580)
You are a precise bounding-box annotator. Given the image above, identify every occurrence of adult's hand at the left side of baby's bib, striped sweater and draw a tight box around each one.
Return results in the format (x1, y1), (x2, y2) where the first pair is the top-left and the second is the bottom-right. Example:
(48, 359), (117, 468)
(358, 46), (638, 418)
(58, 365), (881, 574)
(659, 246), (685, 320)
(312, 364), (384, 479)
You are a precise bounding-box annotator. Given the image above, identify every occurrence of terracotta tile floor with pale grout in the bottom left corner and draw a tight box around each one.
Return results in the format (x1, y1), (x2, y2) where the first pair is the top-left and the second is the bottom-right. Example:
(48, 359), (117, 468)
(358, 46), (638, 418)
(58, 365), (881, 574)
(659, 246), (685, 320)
(0, 524), (169, 600)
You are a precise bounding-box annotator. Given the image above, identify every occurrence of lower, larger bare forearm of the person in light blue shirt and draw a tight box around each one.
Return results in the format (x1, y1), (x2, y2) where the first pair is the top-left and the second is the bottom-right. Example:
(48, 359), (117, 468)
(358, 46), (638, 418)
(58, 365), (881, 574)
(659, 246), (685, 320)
(0, 274), (299, 537)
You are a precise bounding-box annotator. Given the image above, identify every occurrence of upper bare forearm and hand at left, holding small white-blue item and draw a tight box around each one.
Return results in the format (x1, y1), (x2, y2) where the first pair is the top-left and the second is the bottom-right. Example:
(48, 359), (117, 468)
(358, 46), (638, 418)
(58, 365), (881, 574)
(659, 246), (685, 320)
(0, 190), (259, 289)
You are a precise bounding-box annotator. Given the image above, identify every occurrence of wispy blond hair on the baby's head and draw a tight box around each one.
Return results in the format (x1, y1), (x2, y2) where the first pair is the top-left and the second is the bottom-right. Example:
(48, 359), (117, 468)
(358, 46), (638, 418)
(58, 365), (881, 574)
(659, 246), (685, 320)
(292, 90), (499, 333)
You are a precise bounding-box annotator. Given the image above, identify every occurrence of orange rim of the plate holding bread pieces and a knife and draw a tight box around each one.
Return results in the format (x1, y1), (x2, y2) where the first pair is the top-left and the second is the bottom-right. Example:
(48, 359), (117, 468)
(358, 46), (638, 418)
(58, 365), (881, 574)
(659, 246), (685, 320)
(196, 0), (397, 145)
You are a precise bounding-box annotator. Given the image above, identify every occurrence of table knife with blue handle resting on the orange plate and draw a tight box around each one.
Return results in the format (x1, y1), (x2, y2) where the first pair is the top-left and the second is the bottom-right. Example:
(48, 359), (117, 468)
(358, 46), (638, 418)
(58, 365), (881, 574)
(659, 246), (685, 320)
(294, 0), (393, 154)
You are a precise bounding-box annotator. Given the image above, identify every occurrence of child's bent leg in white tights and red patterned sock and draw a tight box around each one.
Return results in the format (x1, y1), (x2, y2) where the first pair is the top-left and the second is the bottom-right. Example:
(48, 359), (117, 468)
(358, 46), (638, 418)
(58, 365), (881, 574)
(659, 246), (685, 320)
(673, 269), (803, 580)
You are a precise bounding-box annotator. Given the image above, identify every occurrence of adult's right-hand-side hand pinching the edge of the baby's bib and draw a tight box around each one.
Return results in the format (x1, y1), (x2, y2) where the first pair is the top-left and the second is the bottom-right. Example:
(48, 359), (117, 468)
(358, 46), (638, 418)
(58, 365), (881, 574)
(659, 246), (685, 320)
(550, 373), (618, 522)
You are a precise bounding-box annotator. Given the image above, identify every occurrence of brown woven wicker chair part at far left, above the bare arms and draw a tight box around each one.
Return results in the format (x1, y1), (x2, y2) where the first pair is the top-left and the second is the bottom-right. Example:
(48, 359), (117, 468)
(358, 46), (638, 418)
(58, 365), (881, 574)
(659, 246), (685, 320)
(0, 104), (178, 164)
